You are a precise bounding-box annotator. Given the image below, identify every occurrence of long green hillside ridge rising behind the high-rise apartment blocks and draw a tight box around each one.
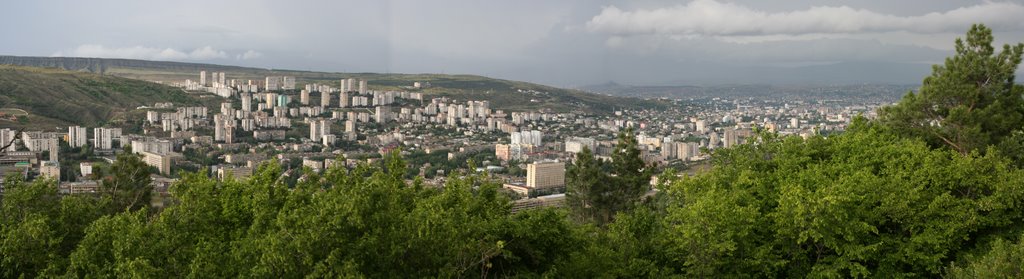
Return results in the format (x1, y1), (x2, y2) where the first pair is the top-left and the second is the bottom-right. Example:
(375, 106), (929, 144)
(0, 55), (666, 114)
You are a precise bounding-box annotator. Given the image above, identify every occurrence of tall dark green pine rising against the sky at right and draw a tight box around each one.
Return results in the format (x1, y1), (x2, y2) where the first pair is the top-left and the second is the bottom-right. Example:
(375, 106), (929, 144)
(880, 25), (1024, 154)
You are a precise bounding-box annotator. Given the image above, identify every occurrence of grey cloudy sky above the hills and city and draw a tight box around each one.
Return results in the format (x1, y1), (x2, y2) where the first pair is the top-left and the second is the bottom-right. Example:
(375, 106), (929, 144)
(0, 0), (1024, 87)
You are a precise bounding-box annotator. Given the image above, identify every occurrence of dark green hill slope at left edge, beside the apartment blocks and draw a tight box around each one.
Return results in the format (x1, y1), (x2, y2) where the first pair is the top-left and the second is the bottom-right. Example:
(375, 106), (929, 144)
(0, 65), (201, 129)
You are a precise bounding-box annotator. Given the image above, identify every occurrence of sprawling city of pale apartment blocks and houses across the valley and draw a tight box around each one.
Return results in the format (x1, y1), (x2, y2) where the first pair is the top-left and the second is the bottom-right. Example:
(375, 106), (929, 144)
(0, 71), (901, 209)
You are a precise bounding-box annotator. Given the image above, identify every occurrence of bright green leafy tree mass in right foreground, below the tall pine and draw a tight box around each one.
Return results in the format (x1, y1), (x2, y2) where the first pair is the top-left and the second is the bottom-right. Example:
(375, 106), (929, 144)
(651, 123), (1024, 277)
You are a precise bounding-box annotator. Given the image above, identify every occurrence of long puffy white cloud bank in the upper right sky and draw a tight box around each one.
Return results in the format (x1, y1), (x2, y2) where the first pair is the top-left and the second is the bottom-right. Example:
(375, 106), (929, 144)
(586, 0), (1024, 37)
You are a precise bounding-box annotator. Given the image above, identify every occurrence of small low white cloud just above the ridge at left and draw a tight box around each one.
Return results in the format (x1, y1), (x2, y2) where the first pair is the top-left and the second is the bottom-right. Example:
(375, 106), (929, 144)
(53, 44), (228, 61)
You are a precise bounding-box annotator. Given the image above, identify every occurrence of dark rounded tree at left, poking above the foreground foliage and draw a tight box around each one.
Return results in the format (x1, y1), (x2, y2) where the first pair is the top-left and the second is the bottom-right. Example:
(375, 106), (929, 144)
(101, 146), (153, 211)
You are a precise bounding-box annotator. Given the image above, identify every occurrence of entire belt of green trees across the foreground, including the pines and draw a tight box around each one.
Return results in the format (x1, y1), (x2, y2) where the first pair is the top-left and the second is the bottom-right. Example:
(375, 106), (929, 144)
(0, 26), (1024, 278)
